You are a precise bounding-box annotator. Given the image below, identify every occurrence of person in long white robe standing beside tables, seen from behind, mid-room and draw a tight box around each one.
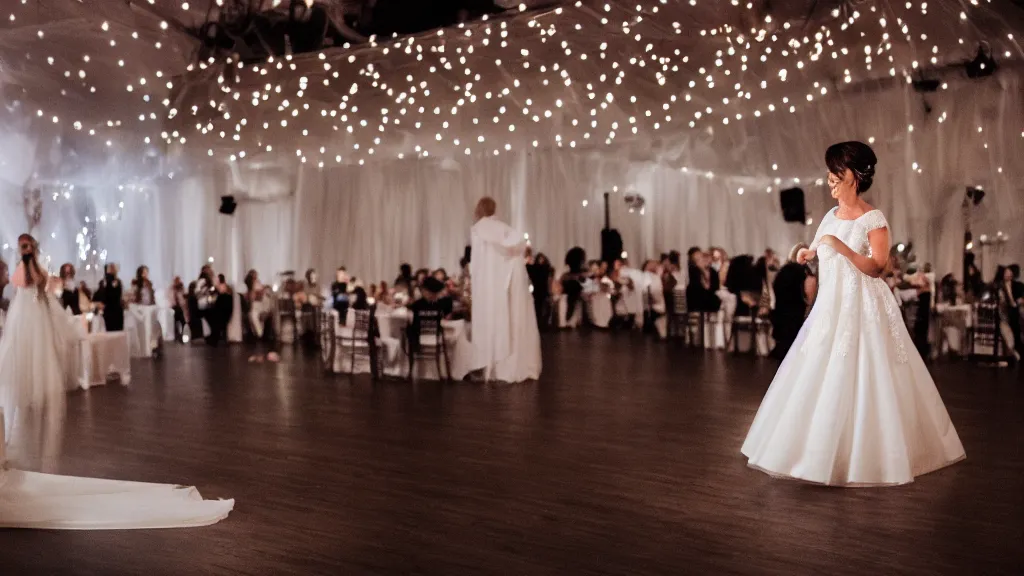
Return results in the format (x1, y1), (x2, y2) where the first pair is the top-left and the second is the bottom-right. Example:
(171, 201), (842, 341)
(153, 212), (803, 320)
(469, 198), (541, 382)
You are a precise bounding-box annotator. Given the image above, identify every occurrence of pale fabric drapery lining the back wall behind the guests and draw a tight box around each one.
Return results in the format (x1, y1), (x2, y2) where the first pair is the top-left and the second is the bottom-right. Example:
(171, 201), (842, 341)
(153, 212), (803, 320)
(0, 71), (1024, 287)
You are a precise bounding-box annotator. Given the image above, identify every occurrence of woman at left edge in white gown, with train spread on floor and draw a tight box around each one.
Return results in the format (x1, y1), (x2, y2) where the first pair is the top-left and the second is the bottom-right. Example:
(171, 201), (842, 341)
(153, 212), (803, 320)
(0, 235), (234, 530)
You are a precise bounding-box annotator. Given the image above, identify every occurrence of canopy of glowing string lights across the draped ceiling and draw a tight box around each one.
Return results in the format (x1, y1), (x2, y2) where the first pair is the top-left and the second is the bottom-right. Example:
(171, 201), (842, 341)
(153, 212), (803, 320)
(0, 0), (1024, 217)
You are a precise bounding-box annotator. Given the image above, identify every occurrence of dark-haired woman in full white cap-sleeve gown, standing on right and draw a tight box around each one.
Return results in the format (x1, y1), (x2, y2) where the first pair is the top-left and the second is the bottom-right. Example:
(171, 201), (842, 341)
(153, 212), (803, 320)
(741, 142), (966, 486)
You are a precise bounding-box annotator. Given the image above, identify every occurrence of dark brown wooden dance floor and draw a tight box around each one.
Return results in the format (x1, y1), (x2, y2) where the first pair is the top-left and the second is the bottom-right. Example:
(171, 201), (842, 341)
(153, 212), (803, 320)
(0, 333), (1024, 576)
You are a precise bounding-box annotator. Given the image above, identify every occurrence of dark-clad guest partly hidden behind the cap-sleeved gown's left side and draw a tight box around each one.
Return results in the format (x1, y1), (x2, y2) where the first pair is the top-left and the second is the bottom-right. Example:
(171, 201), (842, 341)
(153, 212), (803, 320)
(771, 244), (817, 360)
